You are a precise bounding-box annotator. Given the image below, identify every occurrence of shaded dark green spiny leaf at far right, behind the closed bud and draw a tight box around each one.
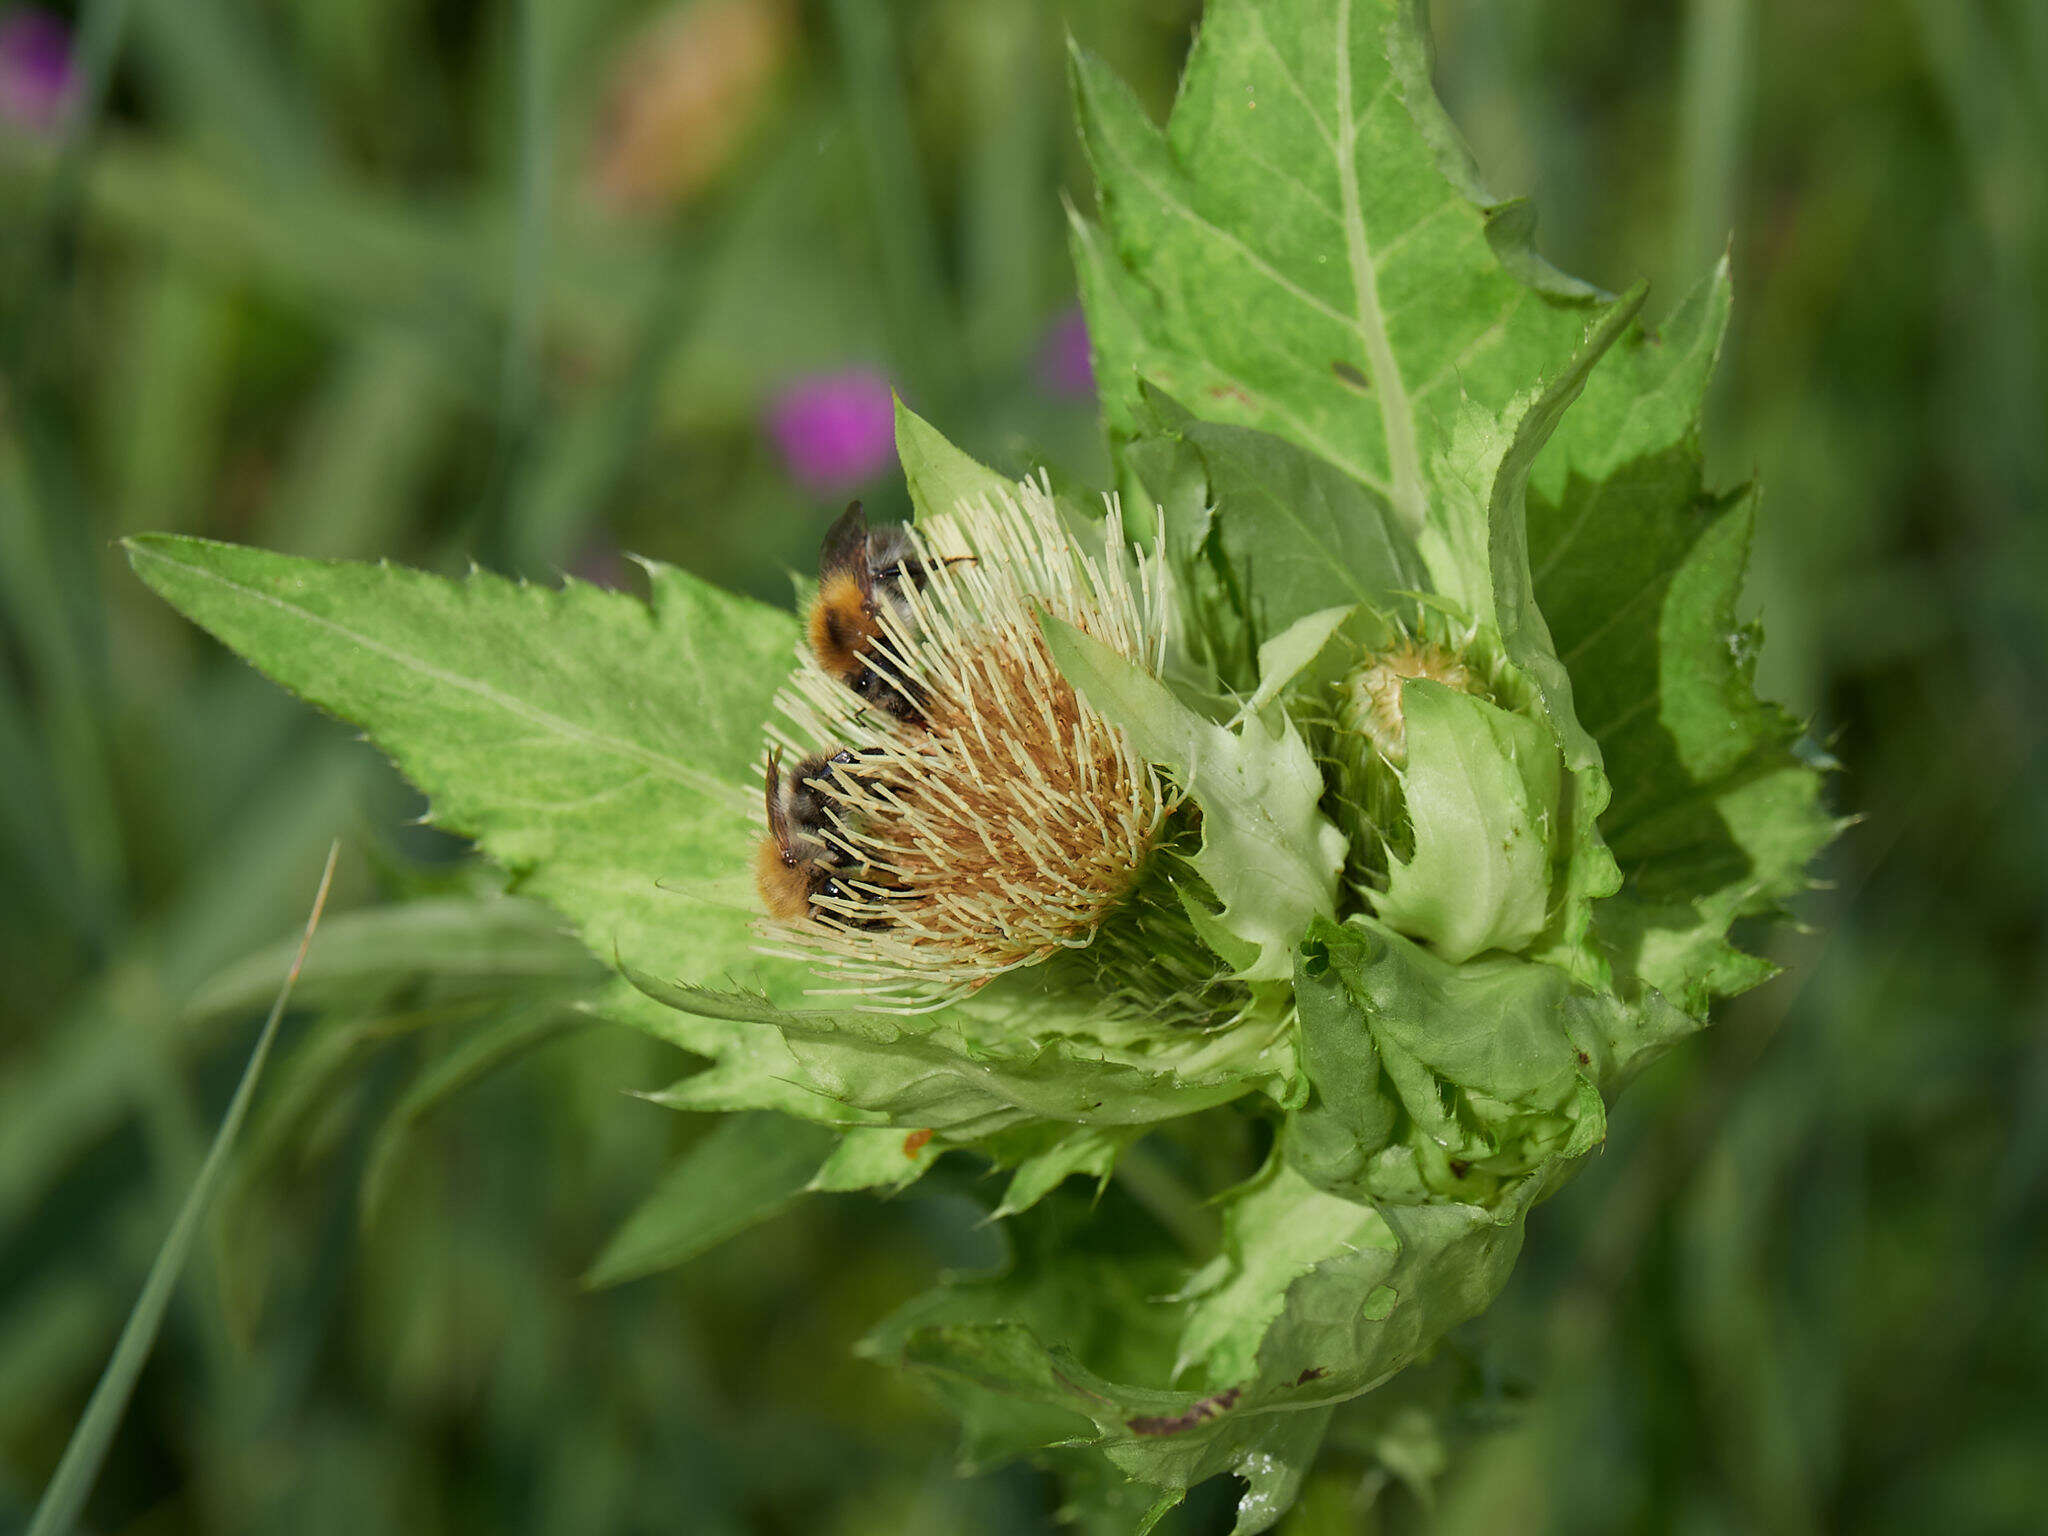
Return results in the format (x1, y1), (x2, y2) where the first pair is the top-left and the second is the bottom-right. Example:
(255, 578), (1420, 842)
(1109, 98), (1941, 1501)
(1528, 262), (1839, 1010)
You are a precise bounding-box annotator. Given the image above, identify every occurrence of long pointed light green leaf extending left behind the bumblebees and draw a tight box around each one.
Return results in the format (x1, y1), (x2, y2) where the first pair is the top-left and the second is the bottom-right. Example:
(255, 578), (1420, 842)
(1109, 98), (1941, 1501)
(129, 537), (823, 1114)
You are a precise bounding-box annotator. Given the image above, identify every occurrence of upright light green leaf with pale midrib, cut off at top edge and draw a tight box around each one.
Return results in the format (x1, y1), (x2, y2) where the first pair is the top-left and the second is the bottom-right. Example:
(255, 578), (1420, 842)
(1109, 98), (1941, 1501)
(1073, 0), (1599, 532)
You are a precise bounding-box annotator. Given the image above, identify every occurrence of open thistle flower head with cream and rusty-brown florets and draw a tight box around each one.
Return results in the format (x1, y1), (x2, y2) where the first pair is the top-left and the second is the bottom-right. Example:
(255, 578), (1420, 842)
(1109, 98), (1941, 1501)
(764, 481), (1178, 1008)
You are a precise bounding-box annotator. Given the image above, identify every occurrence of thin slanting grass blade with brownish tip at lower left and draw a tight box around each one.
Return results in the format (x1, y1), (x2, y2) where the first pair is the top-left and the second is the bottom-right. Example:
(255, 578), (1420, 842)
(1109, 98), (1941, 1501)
(29, 844), (342, 1536)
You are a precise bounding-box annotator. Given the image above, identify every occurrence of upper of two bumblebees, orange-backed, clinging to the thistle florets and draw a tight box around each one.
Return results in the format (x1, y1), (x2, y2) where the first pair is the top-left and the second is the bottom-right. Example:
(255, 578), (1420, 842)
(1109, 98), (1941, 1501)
(809, 502), (932, 725)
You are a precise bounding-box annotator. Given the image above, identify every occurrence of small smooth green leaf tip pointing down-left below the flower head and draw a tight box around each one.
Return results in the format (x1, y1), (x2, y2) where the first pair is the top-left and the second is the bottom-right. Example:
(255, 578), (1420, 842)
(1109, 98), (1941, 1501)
(584, 1110), (840, 1286)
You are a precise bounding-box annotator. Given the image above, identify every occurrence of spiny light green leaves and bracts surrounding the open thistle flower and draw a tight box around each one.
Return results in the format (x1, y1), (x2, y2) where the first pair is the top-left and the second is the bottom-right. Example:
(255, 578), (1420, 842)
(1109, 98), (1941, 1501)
(131, 0), (1833, 1532)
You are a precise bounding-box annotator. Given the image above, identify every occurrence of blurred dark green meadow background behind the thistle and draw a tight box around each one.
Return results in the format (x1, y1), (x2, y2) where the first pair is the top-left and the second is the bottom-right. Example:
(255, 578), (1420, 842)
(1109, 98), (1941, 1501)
(0, 0), (2048, 1536)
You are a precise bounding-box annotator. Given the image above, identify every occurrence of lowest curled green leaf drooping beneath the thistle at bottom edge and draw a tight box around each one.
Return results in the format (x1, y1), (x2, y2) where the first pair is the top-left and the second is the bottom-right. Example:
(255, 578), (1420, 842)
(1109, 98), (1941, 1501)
(870, 1161), (1499, 1532)
